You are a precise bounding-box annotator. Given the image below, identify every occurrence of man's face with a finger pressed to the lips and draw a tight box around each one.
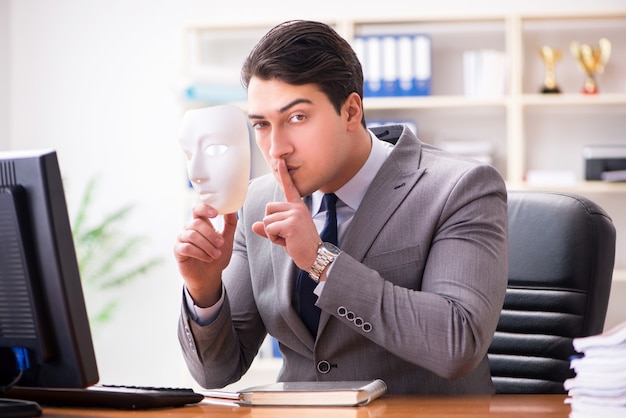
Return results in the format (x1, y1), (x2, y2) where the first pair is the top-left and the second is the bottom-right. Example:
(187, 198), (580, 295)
(248, 77), (354, 196)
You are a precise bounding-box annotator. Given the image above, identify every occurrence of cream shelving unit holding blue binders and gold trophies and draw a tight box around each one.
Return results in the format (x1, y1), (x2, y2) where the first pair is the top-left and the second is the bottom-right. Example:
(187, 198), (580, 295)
(180, 11), (626, 281)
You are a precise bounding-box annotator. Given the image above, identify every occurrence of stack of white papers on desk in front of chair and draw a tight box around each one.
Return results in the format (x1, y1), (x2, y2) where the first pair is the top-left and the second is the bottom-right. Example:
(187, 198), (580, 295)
(564, 322), (626, 418)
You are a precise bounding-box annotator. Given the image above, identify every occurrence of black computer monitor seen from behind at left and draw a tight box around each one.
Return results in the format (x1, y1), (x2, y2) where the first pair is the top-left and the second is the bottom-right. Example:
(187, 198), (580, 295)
(0, 150), (99, 402)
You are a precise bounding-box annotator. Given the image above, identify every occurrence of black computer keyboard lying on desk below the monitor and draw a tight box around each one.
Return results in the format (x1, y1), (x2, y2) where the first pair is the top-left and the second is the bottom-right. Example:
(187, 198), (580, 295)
(4, 385), (204, 409)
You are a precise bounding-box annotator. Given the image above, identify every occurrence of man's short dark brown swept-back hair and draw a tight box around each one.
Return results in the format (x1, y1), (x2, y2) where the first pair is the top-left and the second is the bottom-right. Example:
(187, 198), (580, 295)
(241, 20), (365, 126)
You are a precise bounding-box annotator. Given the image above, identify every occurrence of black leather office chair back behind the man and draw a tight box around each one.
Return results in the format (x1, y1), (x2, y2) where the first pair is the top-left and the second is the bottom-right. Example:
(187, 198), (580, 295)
(488, 191), (615, 393)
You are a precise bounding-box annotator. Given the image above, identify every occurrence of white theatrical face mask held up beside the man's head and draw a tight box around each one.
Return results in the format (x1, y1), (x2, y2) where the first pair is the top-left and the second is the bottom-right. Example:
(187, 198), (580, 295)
(178, 105), (250, 215)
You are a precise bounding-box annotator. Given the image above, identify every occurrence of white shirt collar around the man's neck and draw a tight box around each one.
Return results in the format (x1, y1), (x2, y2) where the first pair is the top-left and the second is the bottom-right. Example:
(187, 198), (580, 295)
(311, 129), (393, 215)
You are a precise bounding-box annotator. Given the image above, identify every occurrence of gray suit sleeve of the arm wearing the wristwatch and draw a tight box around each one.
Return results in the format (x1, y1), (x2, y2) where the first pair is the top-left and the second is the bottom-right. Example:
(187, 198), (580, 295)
(317, 166), (508, 379)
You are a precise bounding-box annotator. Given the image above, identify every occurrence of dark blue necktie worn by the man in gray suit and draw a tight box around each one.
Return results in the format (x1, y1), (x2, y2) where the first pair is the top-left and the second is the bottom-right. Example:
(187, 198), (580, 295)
(296, 193), (339, 337)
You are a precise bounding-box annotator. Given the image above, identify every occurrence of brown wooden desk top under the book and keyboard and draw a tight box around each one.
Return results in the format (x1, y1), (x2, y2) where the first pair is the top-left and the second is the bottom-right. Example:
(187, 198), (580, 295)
(43, 395), (570, 418)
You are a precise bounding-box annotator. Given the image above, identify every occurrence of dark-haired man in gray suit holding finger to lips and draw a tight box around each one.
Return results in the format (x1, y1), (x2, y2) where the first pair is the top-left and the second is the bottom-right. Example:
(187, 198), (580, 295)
(174, 21), (508, 395)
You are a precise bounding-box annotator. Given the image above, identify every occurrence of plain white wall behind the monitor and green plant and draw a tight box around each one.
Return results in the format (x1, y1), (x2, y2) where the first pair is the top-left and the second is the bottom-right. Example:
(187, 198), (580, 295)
(0, 0), (624, 386)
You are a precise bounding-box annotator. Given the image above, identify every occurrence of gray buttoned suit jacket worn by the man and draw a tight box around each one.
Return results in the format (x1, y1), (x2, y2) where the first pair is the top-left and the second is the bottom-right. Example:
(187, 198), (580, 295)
(179, 126), (508, 394)
